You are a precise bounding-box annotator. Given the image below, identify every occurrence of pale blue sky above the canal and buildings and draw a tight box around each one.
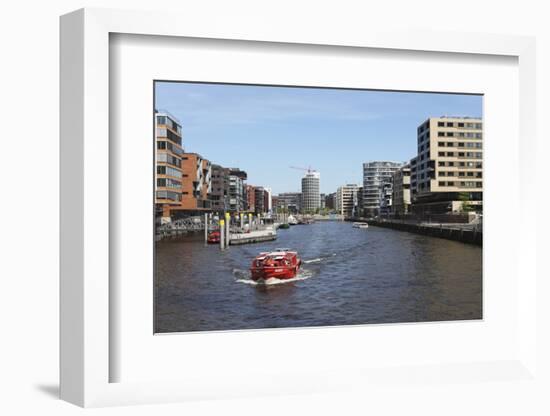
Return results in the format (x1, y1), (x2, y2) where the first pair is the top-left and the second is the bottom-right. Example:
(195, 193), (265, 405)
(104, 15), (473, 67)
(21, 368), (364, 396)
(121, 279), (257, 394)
(155, 82), (482, 194)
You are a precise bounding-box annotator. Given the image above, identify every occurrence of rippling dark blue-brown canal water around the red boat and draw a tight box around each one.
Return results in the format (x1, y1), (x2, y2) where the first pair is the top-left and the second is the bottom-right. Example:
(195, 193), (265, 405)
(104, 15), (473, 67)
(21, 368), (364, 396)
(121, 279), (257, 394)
(155, 221), (482, 332)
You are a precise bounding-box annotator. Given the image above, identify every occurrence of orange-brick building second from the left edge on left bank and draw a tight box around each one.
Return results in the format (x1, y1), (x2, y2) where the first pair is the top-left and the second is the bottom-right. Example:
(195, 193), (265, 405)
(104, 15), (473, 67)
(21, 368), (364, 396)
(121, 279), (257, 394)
(180, 153), (212, 211)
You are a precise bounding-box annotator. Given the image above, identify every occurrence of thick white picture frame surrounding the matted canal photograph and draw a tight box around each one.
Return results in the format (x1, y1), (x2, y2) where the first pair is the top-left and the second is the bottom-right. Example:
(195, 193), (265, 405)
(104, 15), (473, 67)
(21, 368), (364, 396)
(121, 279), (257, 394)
(60, 9), (540, 407)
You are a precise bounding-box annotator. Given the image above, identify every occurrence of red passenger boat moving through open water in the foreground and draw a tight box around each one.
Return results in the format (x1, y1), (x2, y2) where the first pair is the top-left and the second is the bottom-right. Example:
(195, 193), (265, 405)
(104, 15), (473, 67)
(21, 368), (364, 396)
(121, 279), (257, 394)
(250, 248), (302, 281)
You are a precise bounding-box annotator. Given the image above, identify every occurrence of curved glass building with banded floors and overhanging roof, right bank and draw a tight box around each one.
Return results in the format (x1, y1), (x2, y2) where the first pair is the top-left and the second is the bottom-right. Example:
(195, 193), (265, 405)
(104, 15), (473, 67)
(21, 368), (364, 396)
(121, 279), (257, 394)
(363, 161), (403, 217)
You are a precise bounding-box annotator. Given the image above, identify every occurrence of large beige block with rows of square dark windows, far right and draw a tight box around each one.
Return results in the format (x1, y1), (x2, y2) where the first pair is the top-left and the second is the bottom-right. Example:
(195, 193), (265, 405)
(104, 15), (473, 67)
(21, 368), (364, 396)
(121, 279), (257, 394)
(412, 116), (483, 213)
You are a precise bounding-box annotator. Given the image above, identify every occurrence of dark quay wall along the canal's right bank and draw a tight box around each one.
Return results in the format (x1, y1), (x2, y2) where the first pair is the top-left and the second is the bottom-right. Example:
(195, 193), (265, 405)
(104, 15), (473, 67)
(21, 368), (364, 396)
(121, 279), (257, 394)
(365, 220), (483, 246)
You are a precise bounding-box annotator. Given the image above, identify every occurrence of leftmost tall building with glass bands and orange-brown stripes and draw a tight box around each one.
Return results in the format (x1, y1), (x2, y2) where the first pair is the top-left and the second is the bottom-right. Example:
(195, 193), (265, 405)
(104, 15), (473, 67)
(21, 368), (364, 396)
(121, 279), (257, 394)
(155, 111), (183, 220)
